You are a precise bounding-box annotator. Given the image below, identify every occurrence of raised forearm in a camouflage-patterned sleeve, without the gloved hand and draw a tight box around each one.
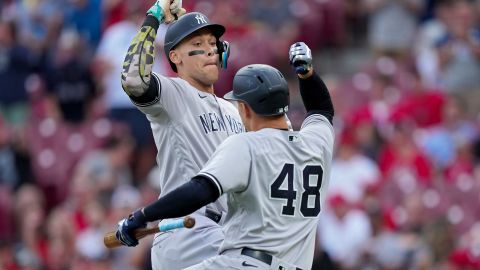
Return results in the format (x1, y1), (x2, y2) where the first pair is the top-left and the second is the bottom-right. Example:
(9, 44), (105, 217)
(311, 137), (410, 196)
(121, 15), (160, 101)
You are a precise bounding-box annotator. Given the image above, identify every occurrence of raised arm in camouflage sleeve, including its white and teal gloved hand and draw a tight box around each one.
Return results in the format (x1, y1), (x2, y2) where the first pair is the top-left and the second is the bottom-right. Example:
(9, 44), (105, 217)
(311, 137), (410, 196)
(121, 0), (184, 104)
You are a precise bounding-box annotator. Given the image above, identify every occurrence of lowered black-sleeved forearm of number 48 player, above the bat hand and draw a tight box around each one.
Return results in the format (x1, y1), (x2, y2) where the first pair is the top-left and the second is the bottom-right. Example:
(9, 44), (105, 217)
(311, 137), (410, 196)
(143, 177), (220, 221)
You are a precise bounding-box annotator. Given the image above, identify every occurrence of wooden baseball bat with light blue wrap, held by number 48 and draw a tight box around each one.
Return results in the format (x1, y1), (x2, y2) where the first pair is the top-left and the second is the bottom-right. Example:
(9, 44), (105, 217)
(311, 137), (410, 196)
(103, 216), (195, 248)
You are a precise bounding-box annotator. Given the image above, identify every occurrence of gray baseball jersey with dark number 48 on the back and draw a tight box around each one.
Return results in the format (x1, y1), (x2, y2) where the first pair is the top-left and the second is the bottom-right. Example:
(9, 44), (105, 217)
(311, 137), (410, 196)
(199, 114), (334, 269)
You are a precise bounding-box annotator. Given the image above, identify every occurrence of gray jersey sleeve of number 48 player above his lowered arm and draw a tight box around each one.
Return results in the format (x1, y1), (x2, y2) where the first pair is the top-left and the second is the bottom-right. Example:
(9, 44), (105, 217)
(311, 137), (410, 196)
(198, 134), (252, 194)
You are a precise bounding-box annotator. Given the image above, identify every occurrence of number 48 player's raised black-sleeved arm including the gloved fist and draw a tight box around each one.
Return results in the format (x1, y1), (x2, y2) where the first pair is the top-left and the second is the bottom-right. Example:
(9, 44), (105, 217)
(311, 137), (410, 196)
(289, 42), (334, 123)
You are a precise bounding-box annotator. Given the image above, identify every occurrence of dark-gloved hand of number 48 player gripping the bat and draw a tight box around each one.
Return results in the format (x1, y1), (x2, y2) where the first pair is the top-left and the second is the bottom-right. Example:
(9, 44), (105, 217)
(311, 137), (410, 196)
(115, 209), (147, 247)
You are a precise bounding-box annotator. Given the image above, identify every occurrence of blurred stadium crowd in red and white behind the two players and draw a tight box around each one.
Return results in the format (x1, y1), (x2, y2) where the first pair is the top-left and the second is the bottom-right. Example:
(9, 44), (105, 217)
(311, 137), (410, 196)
(0, 0), (480, 270)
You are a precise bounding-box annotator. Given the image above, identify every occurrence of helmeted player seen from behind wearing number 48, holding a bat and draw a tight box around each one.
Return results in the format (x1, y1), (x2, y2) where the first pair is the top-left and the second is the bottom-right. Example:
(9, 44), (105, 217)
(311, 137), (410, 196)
(117, 43), (334, 270)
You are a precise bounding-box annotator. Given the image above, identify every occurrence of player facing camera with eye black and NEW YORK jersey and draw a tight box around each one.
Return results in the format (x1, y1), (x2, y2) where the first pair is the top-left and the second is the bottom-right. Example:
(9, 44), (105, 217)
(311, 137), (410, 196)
(121, 0), (244, 270)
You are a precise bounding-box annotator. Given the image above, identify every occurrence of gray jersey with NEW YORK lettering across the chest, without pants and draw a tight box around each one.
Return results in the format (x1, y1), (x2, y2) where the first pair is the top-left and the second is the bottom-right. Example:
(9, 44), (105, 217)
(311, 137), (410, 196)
(137, 73), (245, 200)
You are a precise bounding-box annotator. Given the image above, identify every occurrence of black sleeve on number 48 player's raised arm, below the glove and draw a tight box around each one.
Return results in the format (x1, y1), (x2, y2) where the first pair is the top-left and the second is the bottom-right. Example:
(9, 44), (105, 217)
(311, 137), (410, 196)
(298, 70), (334, 123)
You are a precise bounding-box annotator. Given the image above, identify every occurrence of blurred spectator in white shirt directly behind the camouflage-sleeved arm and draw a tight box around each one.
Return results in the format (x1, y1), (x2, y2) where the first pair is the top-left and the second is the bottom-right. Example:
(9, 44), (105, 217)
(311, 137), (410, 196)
(94, 1), (159, 178)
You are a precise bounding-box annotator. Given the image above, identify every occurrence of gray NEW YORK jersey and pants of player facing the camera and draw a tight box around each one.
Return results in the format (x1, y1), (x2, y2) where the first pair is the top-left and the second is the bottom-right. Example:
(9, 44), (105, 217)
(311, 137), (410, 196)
(137, 73), (244, 270)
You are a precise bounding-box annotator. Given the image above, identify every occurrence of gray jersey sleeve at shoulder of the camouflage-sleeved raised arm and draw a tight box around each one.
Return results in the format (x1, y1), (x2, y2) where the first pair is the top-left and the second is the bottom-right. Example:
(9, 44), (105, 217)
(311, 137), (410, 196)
(132, 73), (187, 117)
